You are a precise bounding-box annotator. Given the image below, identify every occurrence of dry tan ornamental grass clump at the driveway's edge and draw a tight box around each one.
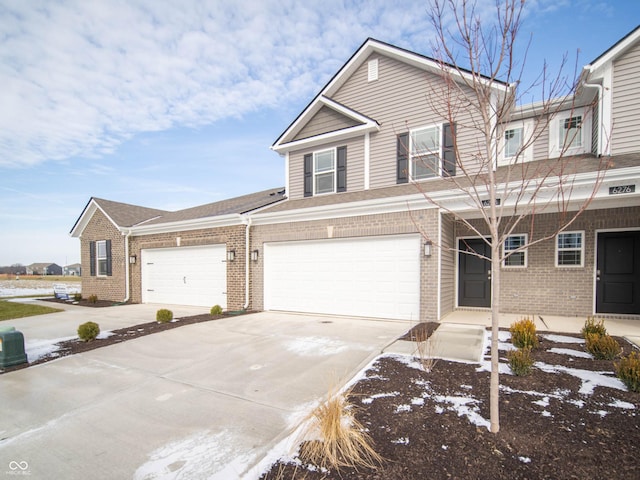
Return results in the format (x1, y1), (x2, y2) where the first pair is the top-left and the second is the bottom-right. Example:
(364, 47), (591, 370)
(300, 393), (382, 470)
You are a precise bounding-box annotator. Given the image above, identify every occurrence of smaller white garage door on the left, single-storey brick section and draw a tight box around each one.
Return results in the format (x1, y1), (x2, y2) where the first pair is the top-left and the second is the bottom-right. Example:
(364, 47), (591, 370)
(141, 244), (227, 309)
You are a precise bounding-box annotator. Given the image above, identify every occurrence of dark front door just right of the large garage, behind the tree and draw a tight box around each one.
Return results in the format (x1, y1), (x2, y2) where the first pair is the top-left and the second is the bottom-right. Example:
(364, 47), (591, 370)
(458, 238), (491, 307)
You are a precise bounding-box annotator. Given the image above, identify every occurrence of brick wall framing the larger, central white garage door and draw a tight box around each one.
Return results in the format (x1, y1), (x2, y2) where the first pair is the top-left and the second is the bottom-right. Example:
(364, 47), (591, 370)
(251, 209), (438, 321)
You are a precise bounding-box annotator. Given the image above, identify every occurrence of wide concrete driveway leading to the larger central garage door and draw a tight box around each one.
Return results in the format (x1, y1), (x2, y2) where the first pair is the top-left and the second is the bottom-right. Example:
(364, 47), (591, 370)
(0, 306), (410, 479)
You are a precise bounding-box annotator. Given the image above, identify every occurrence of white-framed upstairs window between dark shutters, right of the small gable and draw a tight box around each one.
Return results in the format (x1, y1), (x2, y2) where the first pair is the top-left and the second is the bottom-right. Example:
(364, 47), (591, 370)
(409, 125), (442, 180)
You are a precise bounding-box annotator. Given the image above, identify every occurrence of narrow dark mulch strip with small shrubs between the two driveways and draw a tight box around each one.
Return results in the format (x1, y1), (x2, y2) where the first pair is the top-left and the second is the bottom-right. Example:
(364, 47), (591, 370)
(0, 303), (252, 374)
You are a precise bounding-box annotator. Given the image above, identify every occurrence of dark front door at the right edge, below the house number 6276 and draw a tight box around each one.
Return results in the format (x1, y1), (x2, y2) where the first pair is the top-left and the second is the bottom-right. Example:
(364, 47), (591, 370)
(596, 232), (640, 315)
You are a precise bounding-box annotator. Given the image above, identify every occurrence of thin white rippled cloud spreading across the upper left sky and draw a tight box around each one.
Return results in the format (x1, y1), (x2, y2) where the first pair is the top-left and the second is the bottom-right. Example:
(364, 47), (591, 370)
(0, 0), (438, 166)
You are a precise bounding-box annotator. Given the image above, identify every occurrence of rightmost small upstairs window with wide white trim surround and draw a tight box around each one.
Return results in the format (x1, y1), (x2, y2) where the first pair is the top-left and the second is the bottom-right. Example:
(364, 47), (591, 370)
(549, 107), (591, 157)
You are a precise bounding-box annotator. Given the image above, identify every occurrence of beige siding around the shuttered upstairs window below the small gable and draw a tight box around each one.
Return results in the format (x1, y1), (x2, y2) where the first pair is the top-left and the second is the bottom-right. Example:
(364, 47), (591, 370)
(289, 137), (364, 200)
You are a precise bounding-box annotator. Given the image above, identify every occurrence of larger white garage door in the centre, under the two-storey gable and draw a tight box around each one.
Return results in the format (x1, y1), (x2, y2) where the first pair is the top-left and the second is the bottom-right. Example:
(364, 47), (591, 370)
(264, 235), (420, 320)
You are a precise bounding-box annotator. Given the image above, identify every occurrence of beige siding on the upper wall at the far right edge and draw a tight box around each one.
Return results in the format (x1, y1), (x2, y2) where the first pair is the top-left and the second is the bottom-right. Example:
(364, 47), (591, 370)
(611, 43), (640, 155)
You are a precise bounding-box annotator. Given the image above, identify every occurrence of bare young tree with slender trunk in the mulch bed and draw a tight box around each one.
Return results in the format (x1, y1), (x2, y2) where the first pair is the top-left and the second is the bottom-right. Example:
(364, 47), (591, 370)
(407, 0), (607, 432)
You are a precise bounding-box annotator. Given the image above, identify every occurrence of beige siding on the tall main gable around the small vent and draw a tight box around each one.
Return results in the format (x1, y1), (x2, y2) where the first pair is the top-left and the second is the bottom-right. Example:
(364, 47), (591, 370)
(333, 54), (482, 188)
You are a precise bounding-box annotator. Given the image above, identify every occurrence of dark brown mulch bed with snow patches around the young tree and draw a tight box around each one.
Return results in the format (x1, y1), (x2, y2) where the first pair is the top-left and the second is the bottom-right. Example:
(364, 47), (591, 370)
(262, 327), (640, 480)
